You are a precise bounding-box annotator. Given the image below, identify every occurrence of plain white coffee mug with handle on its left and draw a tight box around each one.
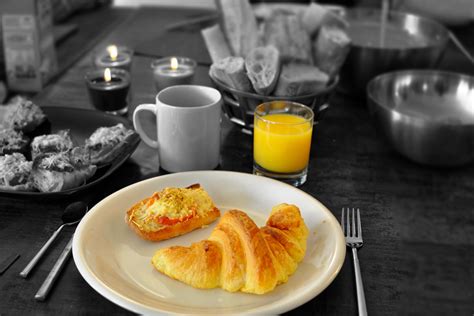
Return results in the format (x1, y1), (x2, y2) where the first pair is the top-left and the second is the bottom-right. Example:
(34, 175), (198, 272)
(133, 85), (222, 172)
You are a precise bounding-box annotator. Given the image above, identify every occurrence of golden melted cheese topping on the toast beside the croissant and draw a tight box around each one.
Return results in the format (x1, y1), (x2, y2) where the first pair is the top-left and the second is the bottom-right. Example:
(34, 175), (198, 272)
(130, 188), (215, 231)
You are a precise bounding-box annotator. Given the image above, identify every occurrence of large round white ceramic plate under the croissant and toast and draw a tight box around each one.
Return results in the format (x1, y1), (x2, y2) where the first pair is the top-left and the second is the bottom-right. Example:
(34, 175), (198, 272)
(73, 171), (346, 315)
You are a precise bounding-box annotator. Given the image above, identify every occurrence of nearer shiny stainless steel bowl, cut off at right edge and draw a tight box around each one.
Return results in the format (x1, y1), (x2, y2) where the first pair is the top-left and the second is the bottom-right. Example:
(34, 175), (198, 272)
(367, 70), (474, 166)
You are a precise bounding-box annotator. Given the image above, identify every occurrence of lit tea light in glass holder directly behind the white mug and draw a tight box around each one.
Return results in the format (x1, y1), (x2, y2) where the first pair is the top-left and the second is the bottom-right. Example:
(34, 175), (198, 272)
(151, 57), (196, 91)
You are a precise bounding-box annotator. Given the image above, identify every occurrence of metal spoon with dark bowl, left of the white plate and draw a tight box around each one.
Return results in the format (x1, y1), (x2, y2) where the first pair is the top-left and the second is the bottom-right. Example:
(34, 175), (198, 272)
(20, 202), (87, 278)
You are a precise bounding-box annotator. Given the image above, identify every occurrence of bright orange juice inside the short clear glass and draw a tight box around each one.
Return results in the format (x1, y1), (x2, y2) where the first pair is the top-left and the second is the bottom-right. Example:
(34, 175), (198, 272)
(253, 114), (313, 173)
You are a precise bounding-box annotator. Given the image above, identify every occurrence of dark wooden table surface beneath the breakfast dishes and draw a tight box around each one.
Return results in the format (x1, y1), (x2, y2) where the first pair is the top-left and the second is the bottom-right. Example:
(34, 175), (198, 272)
(0, 4), (474, 315)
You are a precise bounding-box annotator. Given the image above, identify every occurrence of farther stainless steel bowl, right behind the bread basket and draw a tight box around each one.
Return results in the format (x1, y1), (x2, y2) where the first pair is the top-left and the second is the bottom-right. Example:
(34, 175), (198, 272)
(341, 9), (449, 96)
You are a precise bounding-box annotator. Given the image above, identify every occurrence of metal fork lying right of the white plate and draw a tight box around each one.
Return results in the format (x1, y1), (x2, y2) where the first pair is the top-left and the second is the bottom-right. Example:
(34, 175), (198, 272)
(341, 208), (367, 315)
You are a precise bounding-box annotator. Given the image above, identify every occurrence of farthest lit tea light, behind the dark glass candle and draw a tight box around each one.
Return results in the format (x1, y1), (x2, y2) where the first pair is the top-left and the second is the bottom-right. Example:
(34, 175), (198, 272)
(94, 45), (133, 70)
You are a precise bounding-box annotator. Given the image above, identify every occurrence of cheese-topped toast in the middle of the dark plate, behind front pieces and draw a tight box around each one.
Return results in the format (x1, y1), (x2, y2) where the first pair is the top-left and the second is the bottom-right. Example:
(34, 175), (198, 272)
(31, 130), (74, 159)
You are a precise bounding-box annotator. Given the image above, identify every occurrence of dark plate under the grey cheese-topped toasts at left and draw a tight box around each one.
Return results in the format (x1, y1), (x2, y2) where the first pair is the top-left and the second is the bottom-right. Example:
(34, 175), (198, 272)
(0, 107), (140, 198)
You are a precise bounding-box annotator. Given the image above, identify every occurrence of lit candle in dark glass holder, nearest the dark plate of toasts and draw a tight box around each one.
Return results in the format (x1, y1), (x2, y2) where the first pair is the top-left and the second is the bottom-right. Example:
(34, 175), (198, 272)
(85, 68), (130, 115)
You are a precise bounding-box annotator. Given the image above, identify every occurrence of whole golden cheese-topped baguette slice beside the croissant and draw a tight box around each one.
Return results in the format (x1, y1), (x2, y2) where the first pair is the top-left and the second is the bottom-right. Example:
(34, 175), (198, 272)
(125, 184), (220, 241)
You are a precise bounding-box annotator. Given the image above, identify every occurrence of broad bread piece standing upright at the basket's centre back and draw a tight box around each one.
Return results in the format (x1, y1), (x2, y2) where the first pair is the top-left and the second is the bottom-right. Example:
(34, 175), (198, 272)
(264, 13), (312, 63)
